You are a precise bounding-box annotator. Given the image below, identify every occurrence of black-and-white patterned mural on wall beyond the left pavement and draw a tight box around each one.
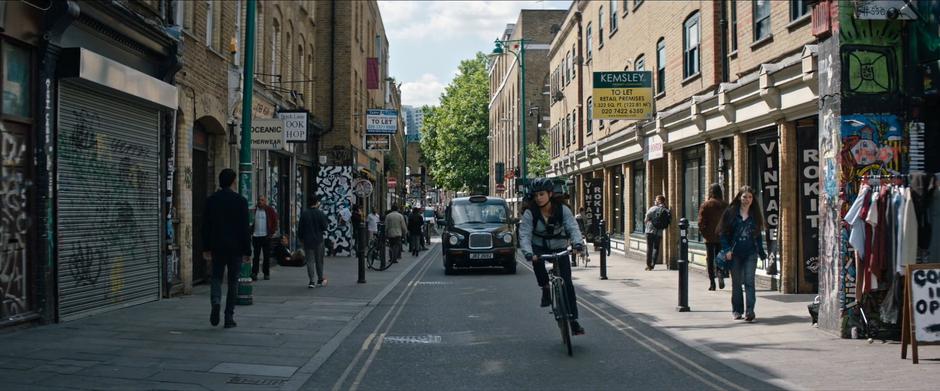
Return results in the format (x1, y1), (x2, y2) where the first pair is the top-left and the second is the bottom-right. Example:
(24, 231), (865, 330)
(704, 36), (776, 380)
(317, 166), (355, 256)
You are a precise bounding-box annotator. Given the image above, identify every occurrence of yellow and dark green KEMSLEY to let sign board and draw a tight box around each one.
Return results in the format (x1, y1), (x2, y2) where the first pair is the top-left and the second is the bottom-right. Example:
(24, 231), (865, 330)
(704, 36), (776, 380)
(592, 71), (653, 120)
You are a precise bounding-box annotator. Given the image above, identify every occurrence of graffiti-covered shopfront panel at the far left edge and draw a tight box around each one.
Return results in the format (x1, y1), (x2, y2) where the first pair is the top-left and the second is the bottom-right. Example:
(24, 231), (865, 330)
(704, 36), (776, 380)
(0, 124), (31, 320)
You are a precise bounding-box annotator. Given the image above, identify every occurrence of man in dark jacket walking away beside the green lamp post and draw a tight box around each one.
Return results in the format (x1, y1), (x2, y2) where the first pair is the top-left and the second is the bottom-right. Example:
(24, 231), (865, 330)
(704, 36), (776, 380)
(202, 168), (251, 329)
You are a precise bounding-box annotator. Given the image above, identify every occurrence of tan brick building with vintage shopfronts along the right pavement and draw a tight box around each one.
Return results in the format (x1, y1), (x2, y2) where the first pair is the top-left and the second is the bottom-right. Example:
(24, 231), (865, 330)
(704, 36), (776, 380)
(550, 1), (818, 292)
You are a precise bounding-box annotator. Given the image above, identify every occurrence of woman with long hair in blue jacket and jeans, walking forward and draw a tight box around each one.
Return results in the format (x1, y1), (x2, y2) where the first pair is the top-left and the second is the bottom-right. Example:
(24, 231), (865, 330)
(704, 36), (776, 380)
(718, 186), (767, 322)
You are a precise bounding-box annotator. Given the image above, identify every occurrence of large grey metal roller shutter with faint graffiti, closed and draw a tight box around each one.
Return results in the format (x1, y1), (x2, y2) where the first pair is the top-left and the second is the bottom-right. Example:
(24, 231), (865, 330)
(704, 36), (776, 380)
(56, 81), (161, 321)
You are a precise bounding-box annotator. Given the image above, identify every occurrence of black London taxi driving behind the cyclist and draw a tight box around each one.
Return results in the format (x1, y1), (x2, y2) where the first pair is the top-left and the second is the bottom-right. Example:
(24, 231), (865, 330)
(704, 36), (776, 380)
(438, 195), (516, 274)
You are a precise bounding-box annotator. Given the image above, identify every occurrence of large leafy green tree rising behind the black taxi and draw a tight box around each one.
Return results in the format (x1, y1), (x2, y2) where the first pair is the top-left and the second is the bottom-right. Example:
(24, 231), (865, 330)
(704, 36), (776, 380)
(421, 53), (489, 191)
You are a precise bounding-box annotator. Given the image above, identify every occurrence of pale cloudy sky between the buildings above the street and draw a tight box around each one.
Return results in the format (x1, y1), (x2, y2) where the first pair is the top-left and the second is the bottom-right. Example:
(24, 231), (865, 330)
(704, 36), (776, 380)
(379, 1), (571, 106)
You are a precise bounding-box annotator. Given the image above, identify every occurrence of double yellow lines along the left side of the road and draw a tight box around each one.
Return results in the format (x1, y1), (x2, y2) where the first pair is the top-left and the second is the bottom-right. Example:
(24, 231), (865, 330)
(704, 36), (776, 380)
(332, 250), (436, 391)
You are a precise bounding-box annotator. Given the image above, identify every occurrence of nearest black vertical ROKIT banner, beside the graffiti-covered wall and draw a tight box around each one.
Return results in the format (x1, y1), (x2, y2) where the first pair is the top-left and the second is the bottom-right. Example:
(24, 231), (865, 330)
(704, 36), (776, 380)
(796, 119), (819, 292)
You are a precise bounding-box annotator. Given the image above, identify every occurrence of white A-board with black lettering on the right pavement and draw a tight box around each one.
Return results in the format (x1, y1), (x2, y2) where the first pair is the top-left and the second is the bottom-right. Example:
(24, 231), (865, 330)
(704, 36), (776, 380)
(901, 263), (940, 364)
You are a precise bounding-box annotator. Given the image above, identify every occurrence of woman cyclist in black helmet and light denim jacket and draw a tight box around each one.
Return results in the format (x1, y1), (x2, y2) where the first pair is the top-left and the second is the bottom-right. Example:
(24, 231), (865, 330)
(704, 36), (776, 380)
(519, 178), (584, 335)
